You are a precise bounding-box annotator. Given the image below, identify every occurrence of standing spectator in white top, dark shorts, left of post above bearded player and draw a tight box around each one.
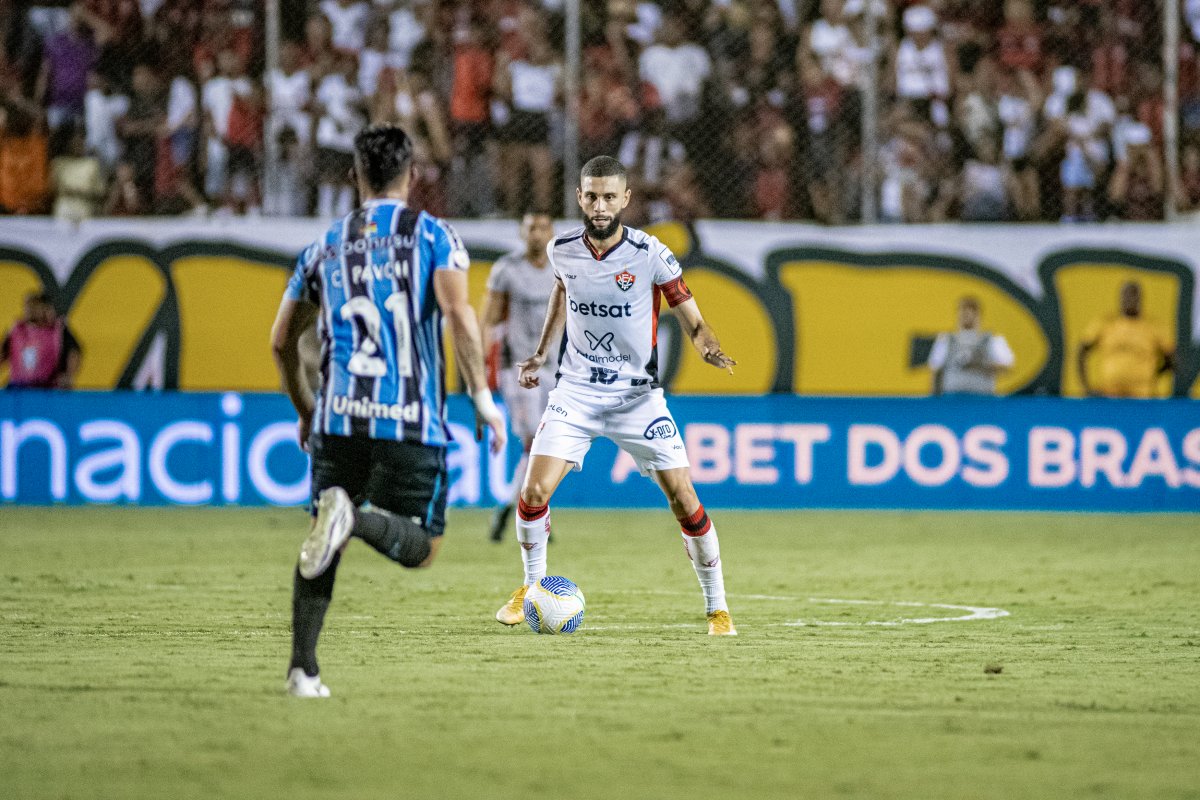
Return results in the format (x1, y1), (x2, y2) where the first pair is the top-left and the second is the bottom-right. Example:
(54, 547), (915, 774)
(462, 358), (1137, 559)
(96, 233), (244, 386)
(493, 25), (563, 217)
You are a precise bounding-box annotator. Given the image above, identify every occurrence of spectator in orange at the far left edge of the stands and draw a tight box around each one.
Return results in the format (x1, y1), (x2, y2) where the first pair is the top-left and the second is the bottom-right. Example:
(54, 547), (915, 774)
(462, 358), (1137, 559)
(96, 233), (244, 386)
(0, 92), (49, 213)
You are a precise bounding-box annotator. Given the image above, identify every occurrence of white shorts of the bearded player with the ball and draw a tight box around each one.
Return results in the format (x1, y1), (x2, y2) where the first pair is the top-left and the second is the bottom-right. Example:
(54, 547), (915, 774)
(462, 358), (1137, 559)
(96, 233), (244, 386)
(529, 386), (689, 475)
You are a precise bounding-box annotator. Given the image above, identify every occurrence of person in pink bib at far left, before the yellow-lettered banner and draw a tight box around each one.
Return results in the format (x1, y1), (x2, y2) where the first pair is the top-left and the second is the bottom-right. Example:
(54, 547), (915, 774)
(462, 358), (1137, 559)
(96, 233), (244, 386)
(0, 293), (82, 389)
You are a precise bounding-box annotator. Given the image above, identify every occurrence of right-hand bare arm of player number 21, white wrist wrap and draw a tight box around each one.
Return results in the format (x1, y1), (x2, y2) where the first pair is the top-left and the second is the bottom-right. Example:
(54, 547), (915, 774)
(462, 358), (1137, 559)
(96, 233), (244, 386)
(433, 270), (506, 452)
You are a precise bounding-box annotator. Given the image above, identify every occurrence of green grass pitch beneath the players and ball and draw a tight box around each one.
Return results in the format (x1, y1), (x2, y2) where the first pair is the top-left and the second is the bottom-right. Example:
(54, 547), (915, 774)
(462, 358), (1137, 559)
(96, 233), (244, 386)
(0, 507), (1200, 800)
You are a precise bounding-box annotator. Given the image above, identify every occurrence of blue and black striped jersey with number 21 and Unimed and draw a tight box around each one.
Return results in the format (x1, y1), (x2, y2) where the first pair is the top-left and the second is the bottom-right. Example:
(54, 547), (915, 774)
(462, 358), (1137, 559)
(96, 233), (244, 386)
(286, 200), (470, 446)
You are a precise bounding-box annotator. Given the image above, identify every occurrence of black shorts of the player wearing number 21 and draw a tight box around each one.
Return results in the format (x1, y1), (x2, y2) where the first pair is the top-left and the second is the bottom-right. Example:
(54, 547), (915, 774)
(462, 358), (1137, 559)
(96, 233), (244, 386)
(308, 433), (448, 536)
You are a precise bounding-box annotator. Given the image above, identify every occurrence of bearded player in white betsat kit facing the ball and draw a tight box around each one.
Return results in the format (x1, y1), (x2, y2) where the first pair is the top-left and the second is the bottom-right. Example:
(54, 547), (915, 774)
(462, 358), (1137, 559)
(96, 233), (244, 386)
(496, 156), (737, 636)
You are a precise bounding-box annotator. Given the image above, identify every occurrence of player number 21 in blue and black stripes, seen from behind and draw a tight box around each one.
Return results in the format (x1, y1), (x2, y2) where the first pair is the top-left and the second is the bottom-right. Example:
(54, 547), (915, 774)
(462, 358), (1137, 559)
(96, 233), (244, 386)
(271, 125), (505, 697)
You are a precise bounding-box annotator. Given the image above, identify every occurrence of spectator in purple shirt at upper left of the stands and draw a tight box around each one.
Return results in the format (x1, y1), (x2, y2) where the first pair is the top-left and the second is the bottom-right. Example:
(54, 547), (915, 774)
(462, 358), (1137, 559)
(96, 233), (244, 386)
(34, 1), (112, 131)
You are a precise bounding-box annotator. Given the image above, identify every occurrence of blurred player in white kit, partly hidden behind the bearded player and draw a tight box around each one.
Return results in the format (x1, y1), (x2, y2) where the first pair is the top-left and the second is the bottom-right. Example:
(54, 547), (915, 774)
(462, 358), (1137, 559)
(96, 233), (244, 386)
(482, 211), (554, 542)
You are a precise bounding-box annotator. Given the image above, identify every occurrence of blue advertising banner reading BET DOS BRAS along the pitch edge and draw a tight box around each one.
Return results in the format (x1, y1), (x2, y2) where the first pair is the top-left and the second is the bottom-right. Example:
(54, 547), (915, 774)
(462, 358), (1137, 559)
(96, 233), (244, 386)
(0, 391), (1200, 512)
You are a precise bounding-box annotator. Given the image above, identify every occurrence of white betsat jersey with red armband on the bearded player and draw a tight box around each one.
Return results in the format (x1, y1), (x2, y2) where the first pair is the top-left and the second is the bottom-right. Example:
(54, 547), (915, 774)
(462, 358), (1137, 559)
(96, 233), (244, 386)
(546, 227), (691, 392)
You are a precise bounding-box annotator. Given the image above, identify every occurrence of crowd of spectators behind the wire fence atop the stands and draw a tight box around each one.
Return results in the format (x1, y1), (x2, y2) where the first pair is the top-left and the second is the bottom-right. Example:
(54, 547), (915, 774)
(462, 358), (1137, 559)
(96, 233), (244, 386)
(0, 0), (1200, 224)
